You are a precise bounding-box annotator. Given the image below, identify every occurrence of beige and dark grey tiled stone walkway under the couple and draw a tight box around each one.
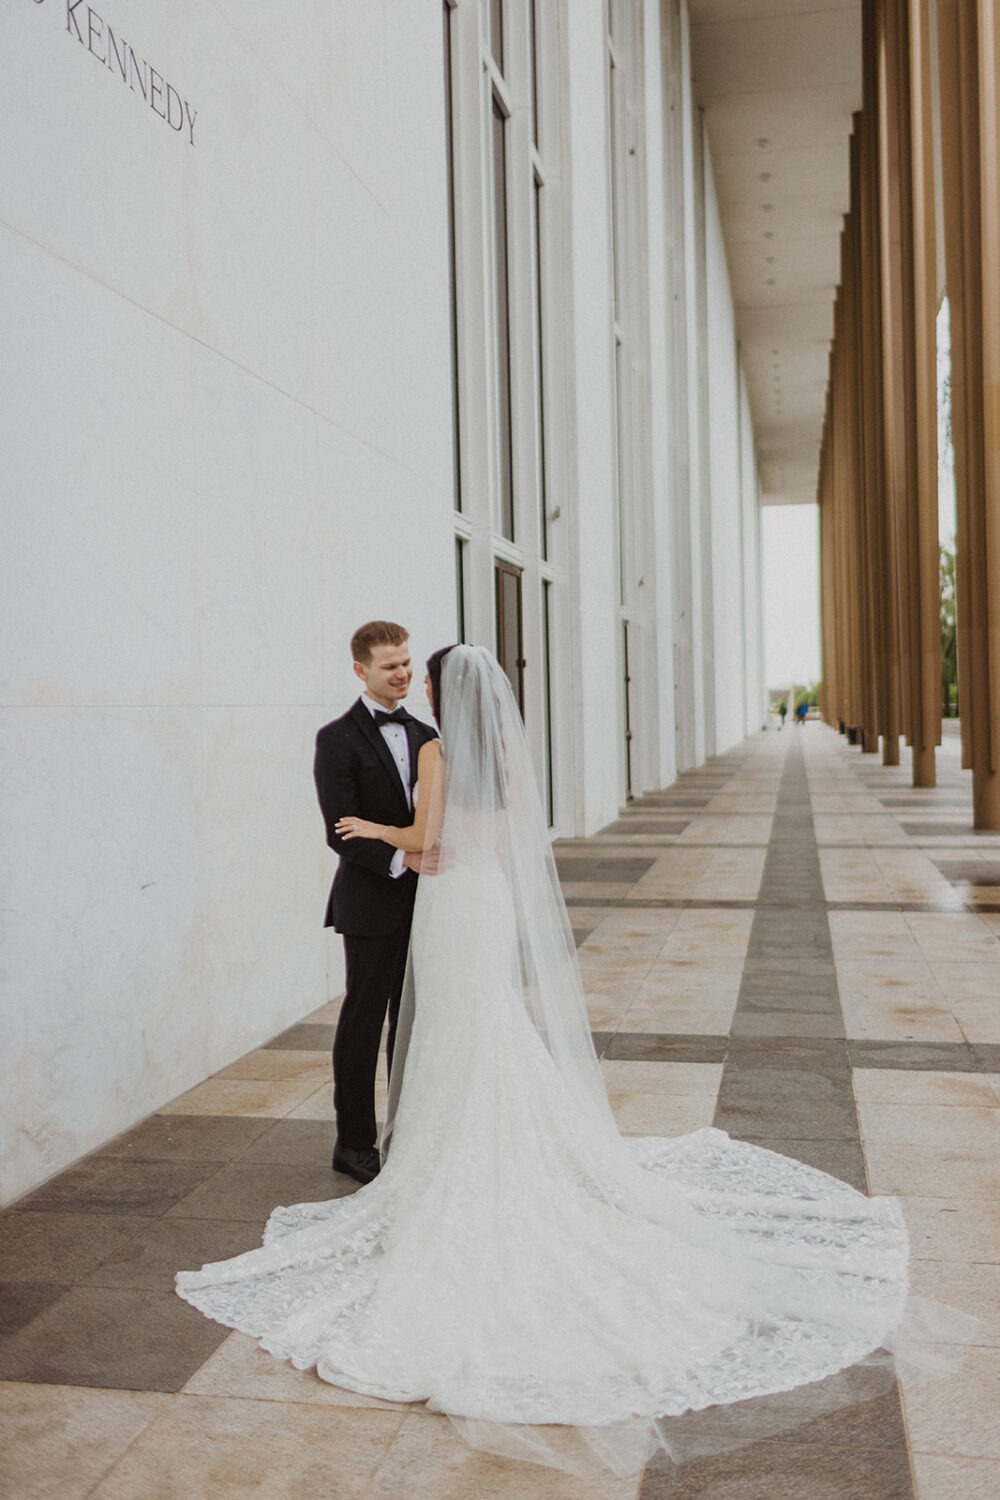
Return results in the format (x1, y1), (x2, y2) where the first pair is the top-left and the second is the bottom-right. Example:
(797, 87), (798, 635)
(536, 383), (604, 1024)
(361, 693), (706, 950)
(0, 725), (1000, 1500)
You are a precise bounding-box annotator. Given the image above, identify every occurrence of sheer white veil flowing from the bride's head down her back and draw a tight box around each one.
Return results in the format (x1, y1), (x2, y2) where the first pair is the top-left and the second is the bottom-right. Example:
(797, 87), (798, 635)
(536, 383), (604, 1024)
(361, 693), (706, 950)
(382, 645), (618, 1155)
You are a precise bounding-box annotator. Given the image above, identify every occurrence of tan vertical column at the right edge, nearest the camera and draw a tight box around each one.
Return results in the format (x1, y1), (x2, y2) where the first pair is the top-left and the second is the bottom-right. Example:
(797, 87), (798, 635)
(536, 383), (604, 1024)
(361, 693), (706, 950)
(937, 0), (1000, 830)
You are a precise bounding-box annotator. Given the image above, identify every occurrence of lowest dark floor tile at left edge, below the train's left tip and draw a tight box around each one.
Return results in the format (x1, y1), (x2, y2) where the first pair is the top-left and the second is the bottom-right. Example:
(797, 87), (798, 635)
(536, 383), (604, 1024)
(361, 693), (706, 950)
(0, 1287), (226, 1391)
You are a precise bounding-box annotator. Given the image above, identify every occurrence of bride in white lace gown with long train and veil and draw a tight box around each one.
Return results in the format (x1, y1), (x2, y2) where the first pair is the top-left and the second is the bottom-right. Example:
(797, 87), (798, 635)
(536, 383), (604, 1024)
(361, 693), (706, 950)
(177, 645), (907, 1467)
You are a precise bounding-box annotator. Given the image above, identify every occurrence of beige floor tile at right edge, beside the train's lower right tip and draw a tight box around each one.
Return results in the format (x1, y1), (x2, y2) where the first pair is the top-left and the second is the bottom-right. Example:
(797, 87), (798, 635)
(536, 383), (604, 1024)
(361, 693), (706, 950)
(900, 1349), (1000, 1458)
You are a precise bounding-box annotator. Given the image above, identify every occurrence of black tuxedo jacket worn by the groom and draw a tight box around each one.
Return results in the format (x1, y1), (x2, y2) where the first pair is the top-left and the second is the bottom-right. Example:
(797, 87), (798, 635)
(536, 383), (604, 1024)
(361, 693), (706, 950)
(315, 699), (438, 938)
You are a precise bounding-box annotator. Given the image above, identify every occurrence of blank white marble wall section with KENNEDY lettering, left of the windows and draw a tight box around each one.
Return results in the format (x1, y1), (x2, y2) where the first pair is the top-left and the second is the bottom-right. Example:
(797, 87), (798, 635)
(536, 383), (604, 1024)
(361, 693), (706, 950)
(0, 0), (454, 1202)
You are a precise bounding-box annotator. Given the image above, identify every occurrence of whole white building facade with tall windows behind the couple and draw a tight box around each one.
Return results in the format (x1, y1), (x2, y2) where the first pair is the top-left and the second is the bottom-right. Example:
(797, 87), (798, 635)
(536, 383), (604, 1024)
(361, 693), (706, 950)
(0, 0), (763, 1203)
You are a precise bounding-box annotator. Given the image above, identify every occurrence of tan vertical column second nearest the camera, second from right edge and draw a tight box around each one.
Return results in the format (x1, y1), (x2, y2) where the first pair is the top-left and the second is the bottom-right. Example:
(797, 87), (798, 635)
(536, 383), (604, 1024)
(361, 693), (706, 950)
(877, 0), (942, 786)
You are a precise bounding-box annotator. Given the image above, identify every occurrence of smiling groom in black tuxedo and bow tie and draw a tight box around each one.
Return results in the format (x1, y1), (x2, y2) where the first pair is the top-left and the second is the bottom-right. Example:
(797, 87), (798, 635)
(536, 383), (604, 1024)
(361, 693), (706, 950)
(315, 620), (436, 1182)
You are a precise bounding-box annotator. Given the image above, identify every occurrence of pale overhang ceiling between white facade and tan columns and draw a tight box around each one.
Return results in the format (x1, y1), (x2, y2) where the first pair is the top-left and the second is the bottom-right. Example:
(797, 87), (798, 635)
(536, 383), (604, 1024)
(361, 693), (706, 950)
(688, 0), (861, 504)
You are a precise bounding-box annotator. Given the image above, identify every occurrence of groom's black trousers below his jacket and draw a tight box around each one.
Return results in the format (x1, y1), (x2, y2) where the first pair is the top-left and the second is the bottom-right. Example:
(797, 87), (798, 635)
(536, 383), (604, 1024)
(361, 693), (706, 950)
(333, 923), (409, 1151)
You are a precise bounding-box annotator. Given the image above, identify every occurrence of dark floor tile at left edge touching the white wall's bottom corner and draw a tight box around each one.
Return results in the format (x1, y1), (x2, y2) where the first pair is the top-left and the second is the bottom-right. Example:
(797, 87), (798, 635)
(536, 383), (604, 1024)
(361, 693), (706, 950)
(0, 1208), (156, 1286)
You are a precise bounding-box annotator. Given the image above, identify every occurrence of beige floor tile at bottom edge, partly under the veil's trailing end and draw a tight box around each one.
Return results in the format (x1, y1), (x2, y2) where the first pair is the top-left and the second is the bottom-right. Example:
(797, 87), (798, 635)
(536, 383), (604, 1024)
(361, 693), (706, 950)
(366, 1413), (639, 1500)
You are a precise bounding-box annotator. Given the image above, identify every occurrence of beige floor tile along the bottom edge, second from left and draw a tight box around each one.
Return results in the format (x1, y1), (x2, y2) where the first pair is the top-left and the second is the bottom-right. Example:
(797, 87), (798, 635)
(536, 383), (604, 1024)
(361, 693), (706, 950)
(93, 1395), (405, 1500)
